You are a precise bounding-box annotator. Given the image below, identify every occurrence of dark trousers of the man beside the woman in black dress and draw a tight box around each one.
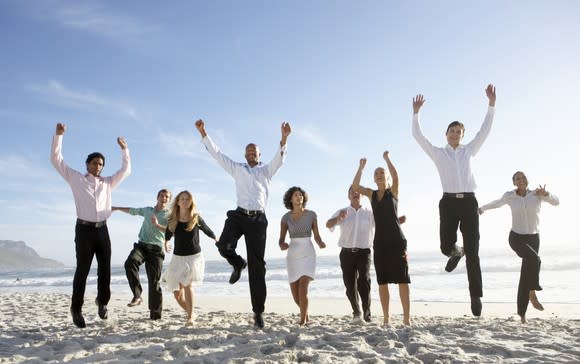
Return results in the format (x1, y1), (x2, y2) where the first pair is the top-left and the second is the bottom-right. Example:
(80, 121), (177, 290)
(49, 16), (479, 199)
(339, 248), (371, 316)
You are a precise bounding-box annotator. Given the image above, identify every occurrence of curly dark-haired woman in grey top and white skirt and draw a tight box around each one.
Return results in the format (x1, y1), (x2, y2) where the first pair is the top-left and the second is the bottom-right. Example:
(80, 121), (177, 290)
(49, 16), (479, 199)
(279, 187), (326, 326)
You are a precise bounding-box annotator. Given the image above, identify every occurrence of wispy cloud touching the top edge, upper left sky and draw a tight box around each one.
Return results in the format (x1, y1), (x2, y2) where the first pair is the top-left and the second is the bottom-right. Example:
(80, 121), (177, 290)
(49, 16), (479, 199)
(49, 1), (156, 43)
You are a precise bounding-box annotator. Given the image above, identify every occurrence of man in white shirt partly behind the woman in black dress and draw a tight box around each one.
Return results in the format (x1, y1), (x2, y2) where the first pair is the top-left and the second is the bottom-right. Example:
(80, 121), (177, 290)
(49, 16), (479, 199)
(326, 186), (375, 322)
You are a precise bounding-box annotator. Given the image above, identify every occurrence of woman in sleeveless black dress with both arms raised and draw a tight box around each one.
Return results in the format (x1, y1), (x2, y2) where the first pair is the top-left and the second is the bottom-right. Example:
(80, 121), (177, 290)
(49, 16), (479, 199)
(352, 151), (411, 325)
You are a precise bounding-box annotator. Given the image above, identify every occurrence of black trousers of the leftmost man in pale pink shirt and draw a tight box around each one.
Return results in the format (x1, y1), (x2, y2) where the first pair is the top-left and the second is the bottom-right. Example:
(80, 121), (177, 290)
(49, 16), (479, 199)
(71, 223), (111, 312)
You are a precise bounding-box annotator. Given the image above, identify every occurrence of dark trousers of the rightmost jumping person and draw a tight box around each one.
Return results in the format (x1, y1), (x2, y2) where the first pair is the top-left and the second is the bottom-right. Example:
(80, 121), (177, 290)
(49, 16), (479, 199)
(509, 231), (542, 316)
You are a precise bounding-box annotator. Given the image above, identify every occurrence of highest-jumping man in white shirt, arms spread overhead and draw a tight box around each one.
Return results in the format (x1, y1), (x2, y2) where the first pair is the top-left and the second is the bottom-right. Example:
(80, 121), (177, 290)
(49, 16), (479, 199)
(413, 84), (496, 316)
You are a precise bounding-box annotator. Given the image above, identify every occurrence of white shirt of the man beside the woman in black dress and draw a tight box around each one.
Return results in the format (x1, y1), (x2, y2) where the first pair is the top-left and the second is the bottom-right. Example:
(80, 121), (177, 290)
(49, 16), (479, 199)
(330, 205), (375, 249)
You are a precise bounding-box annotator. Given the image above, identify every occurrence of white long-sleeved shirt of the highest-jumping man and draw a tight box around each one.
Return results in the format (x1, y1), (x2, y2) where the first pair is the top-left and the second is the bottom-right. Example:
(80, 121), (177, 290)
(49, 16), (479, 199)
(413, 106), (495, 193)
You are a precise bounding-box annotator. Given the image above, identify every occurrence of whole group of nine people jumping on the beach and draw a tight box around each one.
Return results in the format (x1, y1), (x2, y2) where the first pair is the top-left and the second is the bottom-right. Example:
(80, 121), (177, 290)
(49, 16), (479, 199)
(51, 84), (558, 328)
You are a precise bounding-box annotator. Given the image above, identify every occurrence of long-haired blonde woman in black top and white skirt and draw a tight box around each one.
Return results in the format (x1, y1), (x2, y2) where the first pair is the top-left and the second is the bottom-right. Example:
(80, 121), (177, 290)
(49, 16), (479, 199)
(164, 191), (217, 326)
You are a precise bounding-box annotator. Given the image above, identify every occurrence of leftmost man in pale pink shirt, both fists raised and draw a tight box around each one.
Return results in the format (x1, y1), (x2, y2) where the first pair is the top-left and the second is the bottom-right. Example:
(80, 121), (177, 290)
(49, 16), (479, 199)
(50, 123), (131, 328)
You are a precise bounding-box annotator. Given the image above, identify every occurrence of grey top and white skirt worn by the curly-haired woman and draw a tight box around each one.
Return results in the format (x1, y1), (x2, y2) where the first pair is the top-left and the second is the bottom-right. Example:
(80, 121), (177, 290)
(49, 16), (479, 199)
(282, 210), (316, 283)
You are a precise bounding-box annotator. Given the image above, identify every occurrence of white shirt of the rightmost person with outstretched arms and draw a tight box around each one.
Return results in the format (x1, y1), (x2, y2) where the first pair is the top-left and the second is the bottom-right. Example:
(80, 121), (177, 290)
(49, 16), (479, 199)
(480, 190), (560, 234)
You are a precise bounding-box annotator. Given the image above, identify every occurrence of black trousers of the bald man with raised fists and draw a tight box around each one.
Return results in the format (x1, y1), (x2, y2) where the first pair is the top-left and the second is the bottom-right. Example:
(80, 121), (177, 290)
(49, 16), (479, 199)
(216, 210), (268, 313)
